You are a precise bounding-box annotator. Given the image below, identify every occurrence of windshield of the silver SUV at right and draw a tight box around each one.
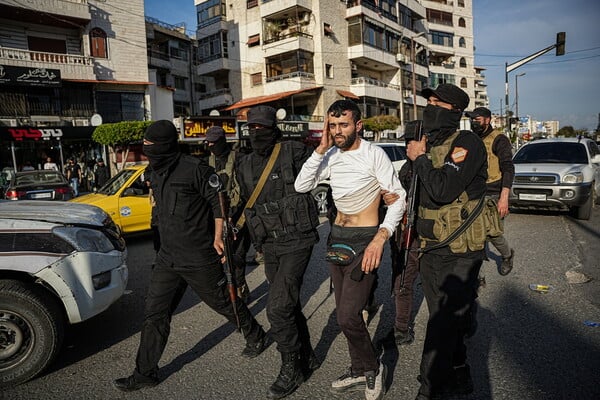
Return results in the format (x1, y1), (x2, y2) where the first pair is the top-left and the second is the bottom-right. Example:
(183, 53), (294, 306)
(513, 142), (588, 164)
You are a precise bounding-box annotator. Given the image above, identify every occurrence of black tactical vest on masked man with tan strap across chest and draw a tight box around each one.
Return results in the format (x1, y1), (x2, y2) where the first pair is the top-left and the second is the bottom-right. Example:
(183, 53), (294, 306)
(239, 142), (319, 245)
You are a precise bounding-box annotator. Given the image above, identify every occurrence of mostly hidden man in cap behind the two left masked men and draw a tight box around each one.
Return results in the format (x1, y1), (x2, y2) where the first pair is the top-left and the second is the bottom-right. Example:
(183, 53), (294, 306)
(206, 126), (252, 302)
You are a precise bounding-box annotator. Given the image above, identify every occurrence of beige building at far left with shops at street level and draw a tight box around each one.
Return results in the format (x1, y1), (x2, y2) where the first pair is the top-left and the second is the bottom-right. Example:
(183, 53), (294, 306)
(0, 0), (150, 170)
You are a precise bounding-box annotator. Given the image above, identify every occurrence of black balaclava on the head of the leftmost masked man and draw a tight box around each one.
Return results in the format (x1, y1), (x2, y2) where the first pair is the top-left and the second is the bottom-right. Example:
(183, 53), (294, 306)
(143, 120), (180, 174)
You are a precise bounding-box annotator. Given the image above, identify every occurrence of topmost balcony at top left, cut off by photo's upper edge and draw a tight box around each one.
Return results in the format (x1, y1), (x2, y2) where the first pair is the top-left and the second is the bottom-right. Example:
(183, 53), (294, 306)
(0, 0), (92, 23)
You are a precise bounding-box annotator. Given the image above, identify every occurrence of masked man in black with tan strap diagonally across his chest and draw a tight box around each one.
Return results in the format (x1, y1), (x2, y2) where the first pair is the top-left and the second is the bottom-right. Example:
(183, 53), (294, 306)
(236, 106), (320, 399)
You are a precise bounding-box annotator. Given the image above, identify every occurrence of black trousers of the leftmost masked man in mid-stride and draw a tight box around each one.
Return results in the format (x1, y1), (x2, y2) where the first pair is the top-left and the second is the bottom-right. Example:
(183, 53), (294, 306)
(134, 263), (264, 380)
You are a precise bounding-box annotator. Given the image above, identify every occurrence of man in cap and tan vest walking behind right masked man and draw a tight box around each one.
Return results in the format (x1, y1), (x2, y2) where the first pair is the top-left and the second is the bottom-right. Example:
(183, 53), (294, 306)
(465, 107), (515, 276)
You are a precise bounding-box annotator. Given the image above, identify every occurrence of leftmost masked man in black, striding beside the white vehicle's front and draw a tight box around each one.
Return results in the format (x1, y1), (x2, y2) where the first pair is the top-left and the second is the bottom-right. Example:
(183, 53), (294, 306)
(114, 120), (265, 391)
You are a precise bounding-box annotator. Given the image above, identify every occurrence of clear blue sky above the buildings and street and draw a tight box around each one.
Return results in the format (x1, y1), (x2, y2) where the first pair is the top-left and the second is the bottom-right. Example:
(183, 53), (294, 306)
(144, 0), (600, 130)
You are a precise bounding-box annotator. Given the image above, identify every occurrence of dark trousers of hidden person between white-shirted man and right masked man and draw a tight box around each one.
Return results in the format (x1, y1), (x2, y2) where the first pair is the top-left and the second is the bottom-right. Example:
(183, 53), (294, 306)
(390, 240), (419, 331)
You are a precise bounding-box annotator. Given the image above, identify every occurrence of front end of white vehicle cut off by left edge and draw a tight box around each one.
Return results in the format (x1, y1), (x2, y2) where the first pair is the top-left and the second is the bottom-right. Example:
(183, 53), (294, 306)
(0, 200), (128, 386)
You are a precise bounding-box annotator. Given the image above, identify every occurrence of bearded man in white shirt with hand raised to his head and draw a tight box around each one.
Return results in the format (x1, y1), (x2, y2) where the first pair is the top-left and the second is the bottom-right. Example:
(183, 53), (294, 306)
(294, 100), (406, 400)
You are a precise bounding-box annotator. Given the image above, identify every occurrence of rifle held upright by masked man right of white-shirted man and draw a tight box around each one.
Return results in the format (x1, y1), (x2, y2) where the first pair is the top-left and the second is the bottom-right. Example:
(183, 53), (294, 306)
(400, 120), (423, 290)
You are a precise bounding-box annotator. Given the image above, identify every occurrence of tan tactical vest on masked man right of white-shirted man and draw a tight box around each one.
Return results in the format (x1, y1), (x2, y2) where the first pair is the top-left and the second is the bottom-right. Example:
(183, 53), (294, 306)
(418, 131), (487, 254)
